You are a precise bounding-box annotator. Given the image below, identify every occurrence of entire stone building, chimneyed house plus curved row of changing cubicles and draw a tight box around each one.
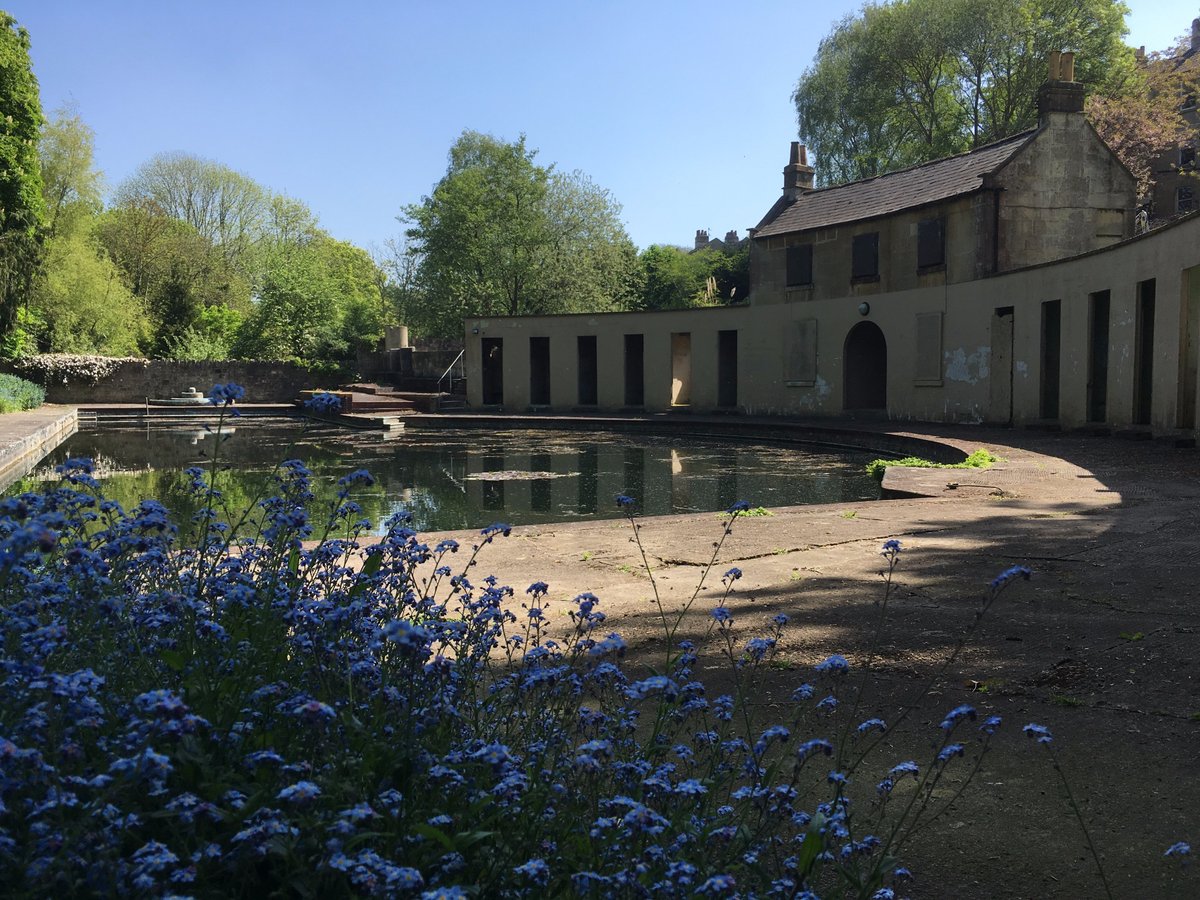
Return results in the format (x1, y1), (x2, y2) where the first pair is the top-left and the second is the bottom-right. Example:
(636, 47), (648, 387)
(466, 54), (1200, 433)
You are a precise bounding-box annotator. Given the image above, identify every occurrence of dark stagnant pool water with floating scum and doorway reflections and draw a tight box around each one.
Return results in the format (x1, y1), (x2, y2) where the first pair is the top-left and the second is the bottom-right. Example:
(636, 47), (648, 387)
(18, 419), (880, 534)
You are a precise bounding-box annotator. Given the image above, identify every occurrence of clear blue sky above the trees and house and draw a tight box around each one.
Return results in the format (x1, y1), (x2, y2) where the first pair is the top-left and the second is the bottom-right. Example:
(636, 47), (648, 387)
(4, 0), (1200, 254)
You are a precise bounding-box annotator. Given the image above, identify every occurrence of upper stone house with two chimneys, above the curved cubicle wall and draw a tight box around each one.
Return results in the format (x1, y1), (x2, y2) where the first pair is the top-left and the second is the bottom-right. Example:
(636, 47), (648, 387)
(750, 53), (1136, 302)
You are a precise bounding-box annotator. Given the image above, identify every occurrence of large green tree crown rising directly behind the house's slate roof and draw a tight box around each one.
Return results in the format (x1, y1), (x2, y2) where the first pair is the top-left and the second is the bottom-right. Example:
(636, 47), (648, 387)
(792, 0), (1134, 185)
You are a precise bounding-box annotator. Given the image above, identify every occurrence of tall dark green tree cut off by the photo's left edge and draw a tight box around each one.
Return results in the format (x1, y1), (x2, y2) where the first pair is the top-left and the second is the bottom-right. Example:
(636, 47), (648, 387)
(0, 12), (44, 334)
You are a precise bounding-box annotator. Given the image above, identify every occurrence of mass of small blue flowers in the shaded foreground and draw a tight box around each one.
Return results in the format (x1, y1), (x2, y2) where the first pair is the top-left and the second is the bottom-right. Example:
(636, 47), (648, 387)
(0, 405), (1123, 898)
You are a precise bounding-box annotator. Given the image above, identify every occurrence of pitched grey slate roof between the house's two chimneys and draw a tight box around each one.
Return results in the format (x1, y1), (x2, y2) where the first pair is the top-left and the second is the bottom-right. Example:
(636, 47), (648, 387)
(755, 130), (1036, 238)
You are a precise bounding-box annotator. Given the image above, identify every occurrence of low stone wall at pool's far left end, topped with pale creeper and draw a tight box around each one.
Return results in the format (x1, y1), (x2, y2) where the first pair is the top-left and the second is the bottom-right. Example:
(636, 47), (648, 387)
(6, 360), (324, 404)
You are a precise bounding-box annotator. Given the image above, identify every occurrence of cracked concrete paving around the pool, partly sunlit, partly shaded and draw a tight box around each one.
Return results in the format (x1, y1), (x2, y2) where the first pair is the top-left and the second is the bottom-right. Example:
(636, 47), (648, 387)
(0, 407), (1200, 898)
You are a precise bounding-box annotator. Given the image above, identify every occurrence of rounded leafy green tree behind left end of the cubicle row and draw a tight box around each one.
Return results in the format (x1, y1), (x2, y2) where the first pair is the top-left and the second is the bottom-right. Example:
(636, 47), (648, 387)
(402, 131), (636, 337)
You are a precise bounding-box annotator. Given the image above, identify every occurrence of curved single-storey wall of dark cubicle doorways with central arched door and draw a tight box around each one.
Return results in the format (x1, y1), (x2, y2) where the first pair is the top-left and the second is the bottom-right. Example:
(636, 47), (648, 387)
(467, 215), (1200, 433)
